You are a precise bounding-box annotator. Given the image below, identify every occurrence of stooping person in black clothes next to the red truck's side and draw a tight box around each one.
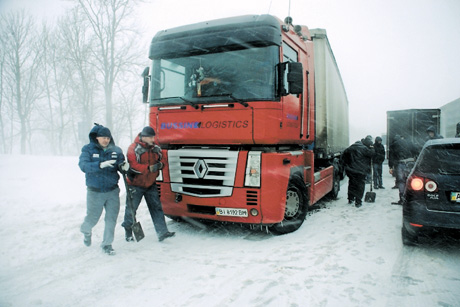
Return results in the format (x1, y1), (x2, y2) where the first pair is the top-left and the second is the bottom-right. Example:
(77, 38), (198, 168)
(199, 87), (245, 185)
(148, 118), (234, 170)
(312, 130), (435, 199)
(342, 137), (374, 208)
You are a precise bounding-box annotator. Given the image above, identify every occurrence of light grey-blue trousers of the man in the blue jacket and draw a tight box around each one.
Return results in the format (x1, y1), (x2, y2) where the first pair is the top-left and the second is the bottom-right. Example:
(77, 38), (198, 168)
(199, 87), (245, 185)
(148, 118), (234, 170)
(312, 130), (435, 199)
(80, 188), (120, 247)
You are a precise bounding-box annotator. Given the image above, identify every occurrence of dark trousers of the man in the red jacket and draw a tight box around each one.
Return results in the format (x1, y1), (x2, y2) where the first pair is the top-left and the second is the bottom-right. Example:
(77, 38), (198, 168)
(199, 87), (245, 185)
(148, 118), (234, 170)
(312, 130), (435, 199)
(121, 184), (168, 237)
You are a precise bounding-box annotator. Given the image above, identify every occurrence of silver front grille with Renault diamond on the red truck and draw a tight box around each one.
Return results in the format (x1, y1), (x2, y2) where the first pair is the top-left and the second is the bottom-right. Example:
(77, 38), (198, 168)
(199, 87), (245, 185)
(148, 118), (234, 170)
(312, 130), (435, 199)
(168, 149), (238, 197)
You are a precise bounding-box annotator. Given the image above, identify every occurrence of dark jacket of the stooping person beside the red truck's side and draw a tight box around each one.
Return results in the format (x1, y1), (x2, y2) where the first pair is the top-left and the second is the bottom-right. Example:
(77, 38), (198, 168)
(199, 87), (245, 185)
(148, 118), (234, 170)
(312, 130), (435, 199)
(342, 141), (374, 175)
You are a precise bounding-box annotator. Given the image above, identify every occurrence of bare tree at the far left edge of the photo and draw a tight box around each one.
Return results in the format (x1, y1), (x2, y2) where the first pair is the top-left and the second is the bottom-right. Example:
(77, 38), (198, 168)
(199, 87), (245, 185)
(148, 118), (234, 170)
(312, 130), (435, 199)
(0, 10), (40, 154)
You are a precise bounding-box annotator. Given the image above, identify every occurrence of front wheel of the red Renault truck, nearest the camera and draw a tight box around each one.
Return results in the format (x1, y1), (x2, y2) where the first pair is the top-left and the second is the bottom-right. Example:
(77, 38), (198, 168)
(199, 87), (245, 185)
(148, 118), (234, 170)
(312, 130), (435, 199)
(270, 178), (308, 235)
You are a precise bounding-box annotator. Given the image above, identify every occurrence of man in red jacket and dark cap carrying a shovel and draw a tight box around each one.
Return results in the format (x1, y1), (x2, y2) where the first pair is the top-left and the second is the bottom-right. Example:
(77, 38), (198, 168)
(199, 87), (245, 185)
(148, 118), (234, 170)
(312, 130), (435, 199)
(121, 126), (175, 242)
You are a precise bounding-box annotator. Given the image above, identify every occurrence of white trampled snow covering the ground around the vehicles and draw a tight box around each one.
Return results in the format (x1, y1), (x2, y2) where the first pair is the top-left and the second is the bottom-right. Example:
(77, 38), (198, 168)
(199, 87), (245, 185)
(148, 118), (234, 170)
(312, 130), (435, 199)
(0, 155), (460, 306)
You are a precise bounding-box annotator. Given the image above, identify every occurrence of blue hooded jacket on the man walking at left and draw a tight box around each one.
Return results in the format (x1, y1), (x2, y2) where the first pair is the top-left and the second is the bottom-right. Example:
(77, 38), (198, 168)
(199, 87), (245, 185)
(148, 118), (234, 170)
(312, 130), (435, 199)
(78, 125), (125, 192)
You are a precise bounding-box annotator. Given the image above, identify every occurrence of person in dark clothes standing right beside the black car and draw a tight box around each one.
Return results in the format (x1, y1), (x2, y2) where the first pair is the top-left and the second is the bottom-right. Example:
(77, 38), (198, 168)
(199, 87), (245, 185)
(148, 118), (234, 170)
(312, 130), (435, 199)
(390, 137), (417, 204)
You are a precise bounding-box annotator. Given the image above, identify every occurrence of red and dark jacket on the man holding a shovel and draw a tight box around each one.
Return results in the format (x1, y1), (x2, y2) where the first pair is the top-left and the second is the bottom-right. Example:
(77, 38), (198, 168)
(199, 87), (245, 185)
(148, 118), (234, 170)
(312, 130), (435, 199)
(127, 133), (162, 188)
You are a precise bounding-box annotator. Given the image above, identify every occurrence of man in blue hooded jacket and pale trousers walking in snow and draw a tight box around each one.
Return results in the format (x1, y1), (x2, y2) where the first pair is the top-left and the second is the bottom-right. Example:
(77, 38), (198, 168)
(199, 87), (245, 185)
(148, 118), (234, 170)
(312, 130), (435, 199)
(78, 124), (129, 255)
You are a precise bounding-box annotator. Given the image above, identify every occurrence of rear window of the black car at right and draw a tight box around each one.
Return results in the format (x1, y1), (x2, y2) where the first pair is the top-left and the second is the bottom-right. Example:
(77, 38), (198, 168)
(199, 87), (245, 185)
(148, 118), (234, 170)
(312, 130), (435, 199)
(417, 144), (460, 175)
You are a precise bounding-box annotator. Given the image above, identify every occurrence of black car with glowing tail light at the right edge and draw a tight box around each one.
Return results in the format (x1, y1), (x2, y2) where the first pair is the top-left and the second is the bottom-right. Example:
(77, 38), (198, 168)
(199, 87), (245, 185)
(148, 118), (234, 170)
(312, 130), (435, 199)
(401, 138), (460, 245)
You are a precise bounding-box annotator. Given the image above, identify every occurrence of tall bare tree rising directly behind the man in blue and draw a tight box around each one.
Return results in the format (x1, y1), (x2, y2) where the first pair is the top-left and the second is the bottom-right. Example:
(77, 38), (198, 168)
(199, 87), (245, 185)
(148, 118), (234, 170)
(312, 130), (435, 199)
(77, 0), (138, 128)
